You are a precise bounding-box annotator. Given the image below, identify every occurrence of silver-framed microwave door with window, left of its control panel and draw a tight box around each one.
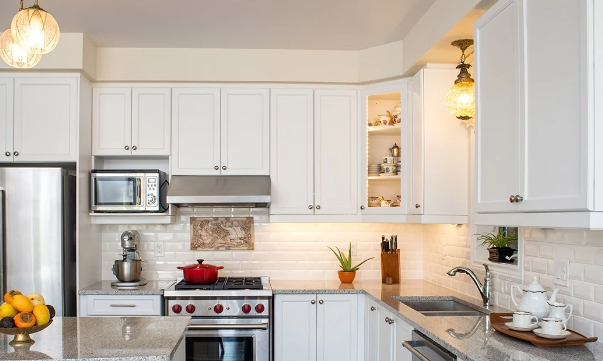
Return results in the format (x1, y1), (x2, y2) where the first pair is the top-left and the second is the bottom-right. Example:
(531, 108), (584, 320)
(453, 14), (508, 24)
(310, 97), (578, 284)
(90, 173), (146, 212)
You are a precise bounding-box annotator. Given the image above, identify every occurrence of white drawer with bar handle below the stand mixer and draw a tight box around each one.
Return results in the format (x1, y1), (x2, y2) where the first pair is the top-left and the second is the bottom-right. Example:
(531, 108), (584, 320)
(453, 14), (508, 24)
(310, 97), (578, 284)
(80, 295), (162, 316)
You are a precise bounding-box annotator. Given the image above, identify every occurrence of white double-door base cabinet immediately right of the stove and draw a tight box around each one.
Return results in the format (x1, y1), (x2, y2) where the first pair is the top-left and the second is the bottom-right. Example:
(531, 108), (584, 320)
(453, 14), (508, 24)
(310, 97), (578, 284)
(274, 294), (359, 361)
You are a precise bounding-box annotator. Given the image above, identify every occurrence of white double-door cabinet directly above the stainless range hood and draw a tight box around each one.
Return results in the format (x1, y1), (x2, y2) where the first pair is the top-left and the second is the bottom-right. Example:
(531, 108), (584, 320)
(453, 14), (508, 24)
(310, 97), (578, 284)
(172, 88), (270, 175)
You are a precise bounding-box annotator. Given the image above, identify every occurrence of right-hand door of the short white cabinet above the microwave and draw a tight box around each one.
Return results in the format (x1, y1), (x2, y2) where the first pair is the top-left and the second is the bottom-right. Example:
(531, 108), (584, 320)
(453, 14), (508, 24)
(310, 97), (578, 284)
(132, 88), (172, 155)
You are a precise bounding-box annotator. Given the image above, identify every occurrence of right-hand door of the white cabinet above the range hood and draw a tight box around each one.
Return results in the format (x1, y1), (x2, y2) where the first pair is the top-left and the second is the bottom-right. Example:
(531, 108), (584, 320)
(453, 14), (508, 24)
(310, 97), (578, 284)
(221, 88), (270, 175)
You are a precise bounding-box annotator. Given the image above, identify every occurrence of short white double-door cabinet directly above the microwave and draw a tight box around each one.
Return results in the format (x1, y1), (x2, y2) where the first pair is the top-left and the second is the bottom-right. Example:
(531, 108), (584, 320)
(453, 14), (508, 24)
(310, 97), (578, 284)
(92, 88), (171, 156)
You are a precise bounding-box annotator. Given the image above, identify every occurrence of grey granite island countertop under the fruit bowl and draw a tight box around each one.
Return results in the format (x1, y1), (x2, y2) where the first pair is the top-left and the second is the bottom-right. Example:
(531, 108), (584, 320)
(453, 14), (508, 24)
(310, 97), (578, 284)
(0, 317), (190, 361)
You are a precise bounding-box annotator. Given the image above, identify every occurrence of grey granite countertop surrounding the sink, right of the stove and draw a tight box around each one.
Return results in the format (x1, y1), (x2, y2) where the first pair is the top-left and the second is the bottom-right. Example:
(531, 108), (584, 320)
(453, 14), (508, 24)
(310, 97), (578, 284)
(270, 280), (603, 361)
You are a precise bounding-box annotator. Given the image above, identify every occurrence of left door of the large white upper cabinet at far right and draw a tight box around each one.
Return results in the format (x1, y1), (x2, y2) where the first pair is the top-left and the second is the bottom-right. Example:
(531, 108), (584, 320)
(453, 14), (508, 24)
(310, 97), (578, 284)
(473, 0), (522, 212)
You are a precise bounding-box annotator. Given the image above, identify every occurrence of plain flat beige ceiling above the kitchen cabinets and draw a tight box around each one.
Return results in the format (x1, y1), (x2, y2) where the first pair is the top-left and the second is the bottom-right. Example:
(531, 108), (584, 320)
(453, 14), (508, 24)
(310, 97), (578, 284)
(0, 0), (435, 50)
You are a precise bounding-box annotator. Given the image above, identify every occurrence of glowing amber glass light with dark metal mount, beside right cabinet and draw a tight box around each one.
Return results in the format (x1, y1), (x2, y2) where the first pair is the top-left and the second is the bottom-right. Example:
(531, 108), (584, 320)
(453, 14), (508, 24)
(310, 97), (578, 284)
(446, 39), (475, 127)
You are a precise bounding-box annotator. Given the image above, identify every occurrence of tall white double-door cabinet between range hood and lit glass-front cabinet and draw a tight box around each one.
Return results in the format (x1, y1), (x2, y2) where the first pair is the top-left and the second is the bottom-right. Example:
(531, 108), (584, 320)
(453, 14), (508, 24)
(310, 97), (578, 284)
(270, 89), (358, 219)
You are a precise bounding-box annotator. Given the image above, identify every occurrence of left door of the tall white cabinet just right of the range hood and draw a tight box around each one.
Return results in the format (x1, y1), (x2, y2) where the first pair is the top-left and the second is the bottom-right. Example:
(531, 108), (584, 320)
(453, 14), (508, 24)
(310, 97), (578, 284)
(270, 89), (314, 214)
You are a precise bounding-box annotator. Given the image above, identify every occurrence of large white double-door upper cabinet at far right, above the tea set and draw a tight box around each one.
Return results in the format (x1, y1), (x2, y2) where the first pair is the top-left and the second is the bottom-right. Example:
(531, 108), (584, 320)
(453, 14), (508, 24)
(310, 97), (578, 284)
(475, 0), (603, 228)
